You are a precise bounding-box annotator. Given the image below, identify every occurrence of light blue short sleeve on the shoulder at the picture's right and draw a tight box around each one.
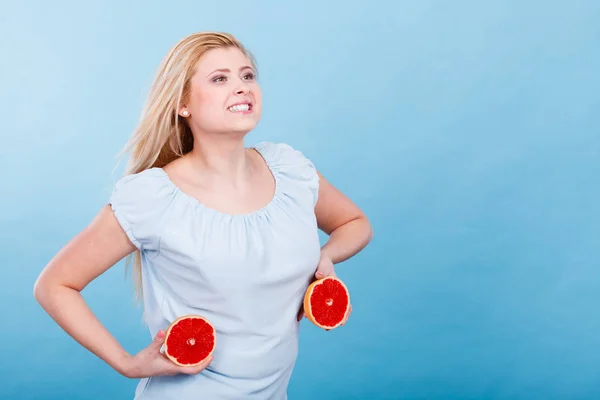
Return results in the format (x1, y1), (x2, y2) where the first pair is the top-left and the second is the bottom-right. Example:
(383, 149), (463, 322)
(254, 143), (319, 206)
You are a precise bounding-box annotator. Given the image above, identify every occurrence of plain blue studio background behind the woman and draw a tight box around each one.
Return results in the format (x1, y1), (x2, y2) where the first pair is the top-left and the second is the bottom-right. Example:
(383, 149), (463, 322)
(0, 0), (600, 400)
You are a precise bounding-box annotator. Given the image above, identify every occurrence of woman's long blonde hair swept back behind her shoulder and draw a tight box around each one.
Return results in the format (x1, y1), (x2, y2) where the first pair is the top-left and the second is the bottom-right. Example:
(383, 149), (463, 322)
(122, 32), (256, 296)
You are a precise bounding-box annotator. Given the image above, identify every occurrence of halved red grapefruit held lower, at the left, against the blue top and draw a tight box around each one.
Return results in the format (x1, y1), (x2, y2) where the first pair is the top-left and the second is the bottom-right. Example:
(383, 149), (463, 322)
(164, 315), (216, 367)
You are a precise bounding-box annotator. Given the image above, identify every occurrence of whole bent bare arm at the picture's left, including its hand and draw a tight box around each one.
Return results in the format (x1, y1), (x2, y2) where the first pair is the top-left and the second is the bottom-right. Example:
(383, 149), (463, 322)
(34, 205), (212, 378)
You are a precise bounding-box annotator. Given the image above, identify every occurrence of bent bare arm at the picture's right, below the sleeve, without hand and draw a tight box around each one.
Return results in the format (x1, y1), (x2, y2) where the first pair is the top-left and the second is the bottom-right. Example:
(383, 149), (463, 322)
(315, 173), (373, 264)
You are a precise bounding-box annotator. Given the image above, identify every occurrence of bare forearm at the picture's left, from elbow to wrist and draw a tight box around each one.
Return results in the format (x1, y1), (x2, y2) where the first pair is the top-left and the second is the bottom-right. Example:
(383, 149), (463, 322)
(35, 285), (131, 376)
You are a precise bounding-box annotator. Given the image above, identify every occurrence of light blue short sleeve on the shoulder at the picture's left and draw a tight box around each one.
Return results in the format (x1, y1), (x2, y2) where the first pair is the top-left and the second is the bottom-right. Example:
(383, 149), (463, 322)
(109, 169), (171, 250)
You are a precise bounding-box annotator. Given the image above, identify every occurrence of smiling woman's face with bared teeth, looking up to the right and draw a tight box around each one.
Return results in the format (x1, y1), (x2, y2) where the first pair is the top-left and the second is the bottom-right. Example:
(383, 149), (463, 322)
(180, 47), (262, 134)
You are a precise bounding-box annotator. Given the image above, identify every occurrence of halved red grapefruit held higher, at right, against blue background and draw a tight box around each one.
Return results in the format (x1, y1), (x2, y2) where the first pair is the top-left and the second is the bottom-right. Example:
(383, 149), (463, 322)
(304, 276), (350, 330)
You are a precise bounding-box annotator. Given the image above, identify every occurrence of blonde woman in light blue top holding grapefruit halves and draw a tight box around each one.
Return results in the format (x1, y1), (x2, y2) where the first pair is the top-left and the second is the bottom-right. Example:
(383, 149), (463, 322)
(34, 33), (372, 400)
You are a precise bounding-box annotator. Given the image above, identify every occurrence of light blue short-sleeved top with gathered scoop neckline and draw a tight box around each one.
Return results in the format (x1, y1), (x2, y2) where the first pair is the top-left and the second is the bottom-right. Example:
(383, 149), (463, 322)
(110, 142), (320, 400)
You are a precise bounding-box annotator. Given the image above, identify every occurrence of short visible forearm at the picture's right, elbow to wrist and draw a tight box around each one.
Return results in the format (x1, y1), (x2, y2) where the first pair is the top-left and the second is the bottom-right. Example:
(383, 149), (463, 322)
(321, 217), (373, 264)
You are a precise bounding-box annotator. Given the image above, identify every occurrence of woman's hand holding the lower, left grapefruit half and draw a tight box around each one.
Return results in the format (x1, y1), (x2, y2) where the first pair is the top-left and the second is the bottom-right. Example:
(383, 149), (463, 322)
(124, 330), (213, 378)
